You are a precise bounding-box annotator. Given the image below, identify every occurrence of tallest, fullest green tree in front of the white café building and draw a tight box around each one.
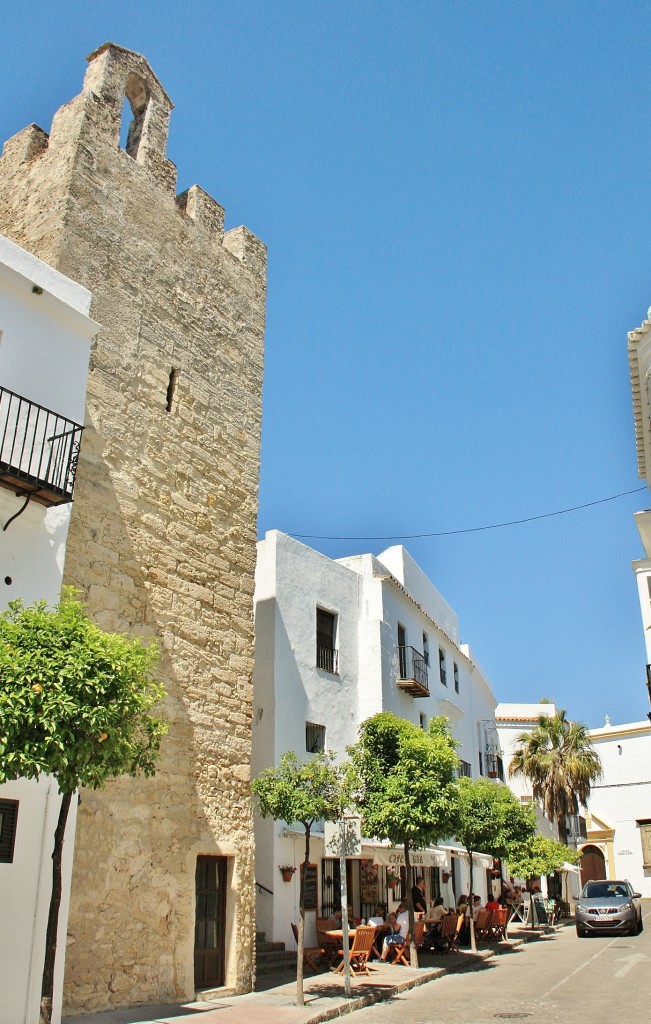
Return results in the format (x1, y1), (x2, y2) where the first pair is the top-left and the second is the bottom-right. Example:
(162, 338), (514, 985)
(348, 712), (459, 967)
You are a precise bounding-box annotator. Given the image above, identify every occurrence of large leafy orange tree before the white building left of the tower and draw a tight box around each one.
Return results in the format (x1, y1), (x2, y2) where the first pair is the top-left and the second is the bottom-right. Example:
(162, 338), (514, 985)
(0, 590), (167, 1024)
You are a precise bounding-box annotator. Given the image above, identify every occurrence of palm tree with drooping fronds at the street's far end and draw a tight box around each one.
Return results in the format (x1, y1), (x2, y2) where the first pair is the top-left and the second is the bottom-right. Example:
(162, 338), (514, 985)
(509, 711), (602, 843)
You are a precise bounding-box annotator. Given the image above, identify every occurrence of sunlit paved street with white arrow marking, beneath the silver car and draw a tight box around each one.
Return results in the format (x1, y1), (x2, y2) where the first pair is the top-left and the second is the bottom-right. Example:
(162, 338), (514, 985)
(354, 914), (651, 1024)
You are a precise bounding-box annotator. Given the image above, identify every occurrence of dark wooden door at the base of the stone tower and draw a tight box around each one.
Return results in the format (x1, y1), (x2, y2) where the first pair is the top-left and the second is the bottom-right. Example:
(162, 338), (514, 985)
(194, 857), (227, 988)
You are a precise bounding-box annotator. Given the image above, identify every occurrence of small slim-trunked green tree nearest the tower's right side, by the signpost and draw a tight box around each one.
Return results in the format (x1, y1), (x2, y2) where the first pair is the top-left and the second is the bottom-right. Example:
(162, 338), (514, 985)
(251, 751), (347, 1007)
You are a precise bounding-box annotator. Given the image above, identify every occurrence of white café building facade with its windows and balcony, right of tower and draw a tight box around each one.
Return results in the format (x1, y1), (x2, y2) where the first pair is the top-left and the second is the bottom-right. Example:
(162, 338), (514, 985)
(252, 530), (504, 943)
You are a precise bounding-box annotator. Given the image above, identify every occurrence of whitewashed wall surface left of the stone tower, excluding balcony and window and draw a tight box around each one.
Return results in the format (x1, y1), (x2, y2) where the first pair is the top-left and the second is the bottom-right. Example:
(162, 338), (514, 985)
(0, 236), (98, 1024)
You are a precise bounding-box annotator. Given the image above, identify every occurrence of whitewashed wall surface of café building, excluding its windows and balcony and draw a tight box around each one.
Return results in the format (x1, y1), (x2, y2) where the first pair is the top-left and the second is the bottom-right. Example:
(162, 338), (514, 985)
(253, 530), (496, 948)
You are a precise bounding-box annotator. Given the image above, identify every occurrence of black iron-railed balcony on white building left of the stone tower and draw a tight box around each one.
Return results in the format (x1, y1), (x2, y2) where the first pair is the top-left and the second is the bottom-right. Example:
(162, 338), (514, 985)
(0, 387), (84, 508)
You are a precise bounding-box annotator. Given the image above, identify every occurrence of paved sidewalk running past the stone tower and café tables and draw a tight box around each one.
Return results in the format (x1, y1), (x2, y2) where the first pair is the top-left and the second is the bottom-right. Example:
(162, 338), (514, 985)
(62, 924), (562, 1024)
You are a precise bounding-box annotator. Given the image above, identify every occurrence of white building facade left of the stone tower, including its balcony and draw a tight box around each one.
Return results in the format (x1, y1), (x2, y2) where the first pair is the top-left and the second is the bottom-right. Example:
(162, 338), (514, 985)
(0, 236), (99, 1024)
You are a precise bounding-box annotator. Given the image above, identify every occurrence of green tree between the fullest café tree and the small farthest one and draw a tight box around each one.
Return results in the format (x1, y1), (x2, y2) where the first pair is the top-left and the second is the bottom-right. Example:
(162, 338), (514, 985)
(453, 778), (535, 951)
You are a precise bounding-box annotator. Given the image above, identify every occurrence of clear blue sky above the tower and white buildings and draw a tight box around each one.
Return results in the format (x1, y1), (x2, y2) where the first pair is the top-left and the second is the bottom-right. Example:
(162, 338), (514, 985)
(0, 6), (651, 726)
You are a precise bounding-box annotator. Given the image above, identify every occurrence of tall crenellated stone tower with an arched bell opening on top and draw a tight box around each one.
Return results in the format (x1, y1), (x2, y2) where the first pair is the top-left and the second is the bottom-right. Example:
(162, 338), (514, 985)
(0, 43), (266, 1012)
